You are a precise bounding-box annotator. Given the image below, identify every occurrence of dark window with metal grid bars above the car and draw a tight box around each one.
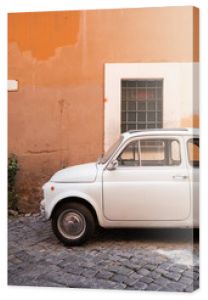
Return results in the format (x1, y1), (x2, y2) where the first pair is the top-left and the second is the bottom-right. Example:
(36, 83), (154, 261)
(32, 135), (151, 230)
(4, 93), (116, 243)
(121, 79), (163, 132)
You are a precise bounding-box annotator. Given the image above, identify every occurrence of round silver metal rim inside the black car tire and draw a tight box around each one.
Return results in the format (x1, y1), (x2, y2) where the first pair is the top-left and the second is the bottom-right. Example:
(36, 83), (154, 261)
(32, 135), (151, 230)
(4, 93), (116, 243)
(57, 209), (86, 239)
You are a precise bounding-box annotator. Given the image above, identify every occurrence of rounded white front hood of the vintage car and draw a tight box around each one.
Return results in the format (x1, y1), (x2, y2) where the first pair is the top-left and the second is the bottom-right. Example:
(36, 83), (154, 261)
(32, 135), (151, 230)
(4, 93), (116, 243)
(50, 163), (97, 182)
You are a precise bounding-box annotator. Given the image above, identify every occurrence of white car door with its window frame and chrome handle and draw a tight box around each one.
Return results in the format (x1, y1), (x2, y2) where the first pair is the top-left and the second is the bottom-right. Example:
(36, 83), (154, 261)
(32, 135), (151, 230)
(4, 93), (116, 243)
(103, 137), (190, 221)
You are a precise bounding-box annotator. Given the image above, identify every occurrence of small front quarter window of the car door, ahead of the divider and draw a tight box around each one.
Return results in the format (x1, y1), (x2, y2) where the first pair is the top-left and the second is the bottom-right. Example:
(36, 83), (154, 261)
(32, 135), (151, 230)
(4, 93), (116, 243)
(117, 141), (139, 167)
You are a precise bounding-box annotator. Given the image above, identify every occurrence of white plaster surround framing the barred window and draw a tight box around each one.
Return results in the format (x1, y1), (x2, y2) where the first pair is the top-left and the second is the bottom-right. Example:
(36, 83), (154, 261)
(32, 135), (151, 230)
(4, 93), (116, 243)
(104, 63), (199, 150)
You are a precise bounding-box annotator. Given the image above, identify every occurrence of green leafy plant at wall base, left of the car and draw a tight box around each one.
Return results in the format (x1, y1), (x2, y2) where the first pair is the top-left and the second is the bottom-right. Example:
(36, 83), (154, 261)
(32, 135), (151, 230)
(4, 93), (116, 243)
(8, 154), (19, 209)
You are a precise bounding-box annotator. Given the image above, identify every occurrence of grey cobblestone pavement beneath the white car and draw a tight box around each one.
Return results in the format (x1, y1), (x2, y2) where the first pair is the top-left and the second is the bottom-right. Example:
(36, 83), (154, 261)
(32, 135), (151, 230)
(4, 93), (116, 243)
(8, 216), (199, 292)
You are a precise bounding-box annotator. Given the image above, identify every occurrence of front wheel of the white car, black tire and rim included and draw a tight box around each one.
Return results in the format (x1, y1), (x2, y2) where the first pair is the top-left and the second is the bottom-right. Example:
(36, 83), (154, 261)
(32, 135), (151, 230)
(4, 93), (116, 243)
(52, 202), (95, 246)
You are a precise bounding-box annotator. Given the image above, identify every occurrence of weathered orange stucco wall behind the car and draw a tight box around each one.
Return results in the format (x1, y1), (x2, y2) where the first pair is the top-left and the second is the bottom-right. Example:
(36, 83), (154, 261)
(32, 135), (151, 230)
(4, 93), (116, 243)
(8, 7), (199, 211)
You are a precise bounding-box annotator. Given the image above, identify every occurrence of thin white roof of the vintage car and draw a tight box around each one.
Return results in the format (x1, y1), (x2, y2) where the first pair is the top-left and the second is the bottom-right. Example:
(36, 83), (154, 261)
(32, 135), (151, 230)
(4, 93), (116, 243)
(122, 128), (199, 138)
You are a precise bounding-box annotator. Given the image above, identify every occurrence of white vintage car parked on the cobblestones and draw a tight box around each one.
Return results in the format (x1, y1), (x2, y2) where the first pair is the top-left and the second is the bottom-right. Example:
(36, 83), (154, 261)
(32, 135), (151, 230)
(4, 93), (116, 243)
(41, 129), (199, 245)
